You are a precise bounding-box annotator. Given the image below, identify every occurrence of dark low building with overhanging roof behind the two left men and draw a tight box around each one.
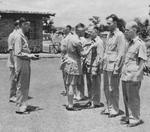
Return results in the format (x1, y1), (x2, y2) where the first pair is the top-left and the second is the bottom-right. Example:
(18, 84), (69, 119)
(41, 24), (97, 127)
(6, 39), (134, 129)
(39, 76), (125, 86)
(0, 10), (55, 53)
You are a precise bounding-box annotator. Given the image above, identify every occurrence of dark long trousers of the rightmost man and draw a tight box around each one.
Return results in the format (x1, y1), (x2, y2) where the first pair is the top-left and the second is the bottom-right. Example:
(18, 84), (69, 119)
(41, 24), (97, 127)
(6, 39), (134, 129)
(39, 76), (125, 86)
(122, 81), (141, 119)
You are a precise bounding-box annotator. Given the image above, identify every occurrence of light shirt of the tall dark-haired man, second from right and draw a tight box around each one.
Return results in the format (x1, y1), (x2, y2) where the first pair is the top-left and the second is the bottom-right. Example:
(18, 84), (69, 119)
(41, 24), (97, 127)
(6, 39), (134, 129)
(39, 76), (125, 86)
(103, 28), (126, 71)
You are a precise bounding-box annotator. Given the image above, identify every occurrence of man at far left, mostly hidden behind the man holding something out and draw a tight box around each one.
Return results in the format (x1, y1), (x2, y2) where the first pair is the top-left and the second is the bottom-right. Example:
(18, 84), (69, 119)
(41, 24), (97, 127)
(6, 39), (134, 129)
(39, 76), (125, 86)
(7, 20), (19, 103)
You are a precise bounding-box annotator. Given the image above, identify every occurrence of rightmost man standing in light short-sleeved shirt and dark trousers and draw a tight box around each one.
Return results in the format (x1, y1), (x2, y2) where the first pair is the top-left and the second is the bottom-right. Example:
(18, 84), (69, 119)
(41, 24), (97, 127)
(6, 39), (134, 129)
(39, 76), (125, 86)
(121, 21), (147, 127)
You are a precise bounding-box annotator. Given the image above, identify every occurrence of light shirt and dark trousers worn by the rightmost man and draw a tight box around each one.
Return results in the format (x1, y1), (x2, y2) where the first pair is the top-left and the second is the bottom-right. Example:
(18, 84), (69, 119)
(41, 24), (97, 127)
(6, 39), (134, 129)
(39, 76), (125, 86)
(121, 37), (147, 123)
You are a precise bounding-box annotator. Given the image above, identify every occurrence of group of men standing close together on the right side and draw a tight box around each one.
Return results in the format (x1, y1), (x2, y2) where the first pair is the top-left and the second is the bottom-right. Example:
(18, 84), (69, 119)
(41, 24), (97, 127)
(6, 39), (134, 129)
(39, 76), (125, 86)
(61, 15), (147, 127)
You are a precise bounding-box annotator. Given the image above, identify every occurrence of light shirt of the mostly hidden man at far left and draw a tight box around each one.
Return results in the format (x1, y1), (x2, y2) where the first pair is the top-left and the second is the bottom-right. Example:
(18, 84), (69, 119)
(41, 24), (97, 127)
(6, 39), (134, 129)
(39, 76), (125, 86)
(7, 30), (17, 68)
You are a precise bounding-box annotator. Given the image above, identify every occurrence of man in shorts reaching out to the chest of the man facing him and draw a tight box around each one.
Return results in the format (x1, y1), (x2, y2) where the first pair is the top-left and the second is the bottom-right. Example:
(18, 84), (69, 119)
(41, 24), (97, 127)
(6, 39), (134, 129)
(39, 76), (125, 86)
(61, 23), (95, 111)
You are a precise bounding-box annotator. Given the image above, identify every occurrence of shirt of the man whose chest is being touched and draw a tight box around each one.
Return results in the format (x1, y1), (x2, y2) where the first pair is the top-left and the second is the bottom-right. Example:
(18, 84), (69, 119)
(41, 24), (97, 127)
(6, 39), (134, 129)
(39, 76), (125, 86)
(85, 36), (104, 74)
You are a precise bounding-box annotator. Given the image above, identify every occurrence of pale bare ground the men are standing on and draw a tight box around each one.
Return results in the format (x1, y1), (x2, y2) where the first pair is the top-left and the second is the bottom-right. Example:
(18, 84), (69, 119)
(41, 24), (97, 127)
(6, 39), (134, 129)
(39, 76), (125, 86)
(0, 58), (150, 132)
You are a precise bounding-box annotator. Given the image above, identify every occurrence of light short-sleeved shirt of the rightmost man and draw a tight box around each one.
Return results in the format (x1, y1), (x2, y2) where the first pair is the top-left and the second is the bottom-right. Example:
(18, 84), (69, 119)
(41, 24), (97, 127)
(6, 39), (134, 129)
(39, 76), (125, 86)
(121, 37), (147, 81)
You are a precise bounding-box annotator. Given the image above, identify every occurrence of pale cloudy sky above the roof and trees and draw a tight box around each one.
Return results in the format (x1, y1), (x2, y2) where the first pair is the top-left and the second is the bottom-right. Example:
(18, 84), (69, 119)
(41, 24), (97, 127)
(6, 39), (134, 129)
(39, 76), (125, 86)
(0, 0), (150, 26)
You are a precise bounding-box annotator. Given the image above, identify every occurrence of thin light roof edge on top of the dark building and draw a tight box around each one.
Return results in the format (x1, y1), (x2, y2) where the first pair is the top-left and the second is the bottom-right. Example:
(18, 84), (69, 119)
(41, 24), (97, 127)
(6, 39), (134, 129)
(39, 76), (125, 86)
(0, 10), (55, 16)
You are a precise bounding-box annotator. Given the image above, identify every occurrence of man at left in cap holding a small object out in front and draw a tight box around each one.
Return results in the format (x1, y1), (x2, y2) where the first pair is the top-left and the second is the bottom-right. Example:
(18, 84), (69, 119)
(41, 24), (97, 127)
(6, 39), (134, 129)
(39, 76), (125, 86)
(14, 18), (37, 114)
